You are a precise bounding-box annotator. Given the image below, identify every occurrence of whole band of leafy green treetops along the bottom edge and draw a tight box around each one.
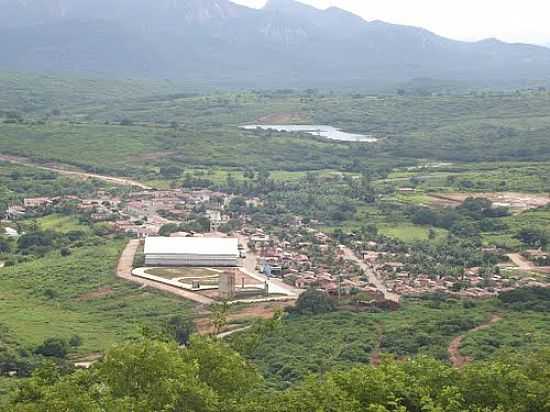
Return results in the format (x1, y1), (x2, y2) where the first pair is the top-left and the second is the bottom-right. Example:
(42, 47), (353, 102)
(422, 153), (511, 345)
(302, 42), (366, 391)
(9, 338), (550, 412)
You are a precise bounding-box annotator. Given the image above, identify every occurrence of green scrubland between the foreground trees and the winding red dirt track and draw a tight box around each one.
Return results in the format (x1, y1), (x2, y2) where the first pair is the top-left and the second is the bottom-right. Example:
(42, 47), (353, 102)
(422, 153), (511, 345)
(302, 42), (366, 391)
(230, 300), (492, 388)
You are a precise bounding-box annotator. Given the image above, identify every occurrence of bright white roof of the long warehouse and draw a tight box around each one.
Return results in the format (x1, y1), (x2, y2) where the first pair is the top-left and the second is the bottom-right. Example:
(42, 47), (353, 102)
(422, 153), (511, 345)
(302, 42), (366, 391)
(145, 237), (239, 256)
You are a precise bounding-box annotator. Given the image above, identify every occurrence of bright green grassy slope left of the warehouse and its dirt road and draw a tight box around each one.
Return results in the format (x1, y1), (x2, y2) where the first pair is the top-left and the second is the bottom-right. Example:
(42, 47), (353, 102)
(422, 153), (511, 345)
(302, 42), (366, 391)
(0, 241), (196, 353)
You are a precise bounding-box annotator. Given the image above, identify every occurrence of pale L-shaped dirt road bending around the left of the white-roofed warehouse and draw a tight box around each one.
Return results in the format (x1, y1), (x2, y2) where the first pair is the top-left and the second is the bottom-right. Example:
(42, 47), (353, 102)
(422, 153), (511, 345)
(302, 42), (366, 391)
(116, 239), (215, 305)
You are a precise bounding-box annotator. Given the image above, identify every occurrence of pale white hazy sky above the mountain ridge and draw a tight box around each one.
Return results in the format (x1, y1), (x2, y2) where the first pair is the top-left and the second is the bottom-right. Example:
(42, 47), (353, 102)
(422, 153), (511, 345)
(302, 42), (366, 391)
(233, 0), (550, 43)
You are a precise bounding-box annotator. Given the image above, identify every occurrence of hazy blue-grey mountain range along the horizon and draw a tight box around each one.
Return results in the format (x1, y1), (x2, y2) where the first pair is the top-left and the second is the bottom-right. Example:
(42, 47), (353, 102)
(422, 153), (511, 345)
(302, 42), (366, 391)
(0, 0), (550, 88)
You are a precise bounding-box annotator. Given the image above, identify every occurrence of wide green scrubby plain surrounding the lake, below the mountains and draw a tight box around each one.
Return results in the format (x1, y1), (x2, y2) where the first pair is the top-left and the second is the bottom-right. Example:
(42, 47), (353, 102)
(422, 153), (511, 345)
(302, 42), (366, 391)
(0, 78), (550, 177)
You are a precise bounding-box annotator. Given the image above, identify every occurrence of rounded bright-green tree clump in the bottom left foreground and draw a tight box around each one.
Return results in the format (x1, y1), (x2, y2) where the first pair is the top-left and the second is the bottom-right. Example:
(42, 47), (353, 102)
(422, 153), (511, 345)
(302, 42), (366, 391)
(8, 337), (260, 412)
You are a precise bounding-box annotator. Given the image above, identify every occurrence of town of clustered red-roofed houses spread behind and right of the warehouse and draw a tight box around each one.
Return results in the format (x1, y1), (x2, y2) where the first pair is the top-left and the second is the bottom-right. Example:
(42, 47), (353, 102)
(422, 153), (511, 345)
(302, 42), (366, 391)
(4, 183), (550, 305)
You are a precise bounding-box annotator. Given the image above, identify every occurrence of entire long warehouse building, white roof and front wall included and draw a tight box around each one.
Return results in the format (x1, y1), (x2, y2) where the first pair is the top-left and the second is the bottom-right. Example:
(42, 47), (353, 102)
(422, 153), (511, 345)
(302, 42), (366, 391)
(144, 237), (239, 267)
